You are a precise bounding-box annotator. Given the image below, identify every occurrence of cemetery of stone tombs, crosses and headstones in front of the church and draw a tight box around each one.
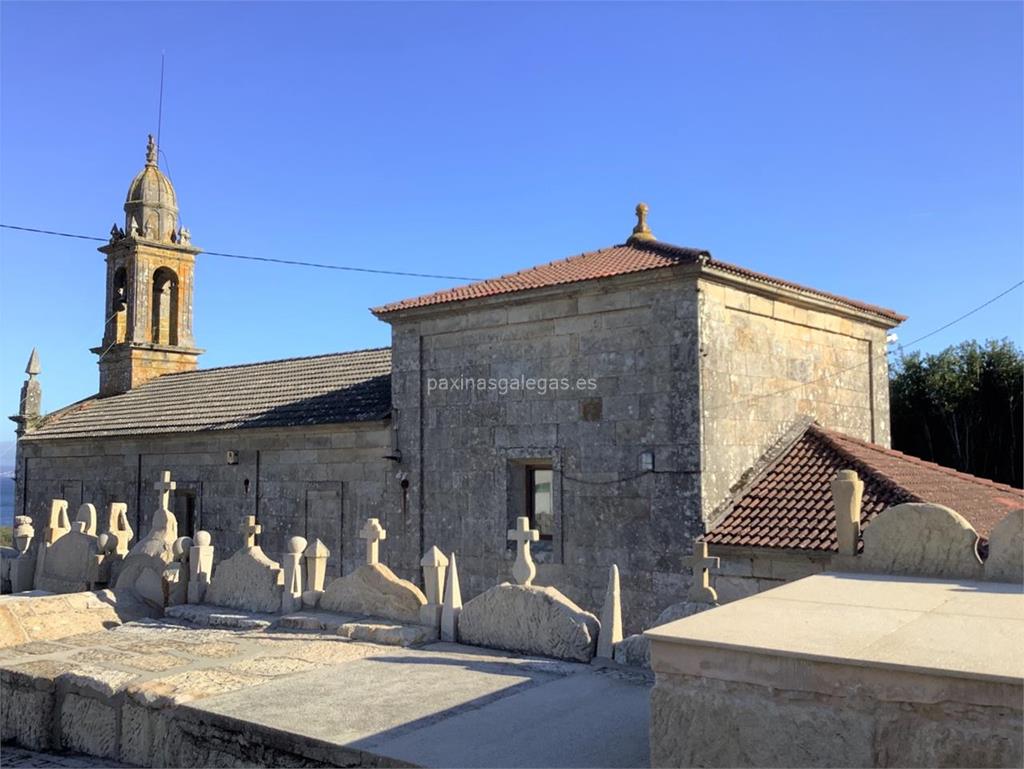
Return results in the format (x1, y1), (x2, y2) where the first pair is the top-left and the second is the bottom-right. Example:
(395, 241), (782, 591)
(0, 471), (1024, 767)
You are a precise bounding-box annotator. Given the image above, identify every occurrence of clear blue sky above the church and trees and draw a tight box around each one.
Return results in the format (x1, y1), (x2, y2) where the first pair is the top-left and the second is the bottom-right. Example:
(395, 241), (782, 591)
(0, 2), (1024, 456)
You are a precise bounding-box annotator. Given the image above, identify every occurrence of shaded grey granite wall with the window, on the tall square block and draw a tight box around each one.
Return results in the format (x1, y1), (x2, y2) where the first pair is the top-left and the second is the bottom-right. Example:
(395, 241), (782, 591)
(388, 271), (700, 630)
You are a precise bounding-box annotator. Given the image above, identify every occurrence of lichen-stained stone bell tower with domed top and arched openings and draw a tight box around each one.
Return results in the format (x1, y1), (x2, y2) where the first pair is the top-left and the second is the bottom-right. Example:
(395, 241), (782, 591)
(92, 134), (203, 396)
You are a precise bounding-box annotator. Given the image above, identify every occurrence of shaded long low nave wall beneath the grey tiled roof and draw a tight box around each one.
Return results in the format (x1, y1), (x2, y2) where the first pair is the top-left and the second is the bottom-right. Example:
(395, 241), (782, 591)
(15, 422), (393, 575)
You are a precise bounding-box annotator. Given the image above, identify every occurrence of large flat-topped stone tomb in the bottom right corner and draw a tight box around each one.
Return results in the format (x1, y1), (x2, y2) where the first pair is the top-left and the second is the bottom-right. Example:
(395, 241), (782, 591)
(646, 574), (1024, 767)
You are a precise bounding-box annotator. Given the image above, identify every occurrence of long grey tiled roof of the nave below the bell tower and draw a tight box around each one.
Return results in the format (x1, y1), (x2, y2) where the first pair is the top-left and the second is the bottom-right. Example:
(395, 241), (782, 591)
(25, 347), (391, 439)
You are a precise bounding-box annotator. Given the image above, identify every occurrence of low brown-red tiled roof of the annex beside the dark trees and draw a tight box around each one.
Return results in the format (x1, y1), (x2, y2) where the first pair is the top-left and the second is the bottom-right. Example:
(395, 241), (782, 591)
(705, 425), (1024, 551)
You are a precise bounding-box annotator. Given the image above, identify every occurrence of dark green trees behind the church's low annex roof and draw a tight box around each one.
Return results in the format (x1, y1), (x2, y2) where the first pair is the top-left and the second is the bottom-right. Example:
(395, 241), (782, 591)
(889, 339), (1024, 487)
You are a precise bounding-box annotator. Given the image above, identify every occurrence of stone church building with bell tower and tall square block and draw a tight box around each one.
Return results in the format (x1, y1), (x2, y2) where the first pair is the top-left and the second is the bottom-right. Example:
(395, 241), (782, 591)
(14, 139), (1007, 628)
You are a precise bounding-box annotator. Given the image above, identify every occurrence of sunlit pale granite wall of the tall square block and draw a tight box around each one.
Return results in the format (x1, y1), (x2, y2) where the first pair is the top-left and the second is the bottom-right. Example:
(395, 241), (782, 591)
(699, 279), (890, 519)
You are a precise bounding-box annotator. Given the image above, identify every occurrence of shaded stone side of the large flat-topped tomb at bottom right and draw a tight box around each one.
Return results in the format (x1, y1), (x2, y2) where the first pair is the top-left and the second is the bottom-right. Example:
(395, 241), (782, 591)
(650, 664), (1022, 767)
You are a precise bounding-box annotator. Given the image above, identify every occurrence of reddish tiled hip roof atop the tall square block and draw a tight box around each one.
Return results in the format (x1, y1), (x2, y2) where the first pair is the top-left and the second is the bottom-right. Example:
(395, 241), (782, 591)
(373, 241), (906, 323)
